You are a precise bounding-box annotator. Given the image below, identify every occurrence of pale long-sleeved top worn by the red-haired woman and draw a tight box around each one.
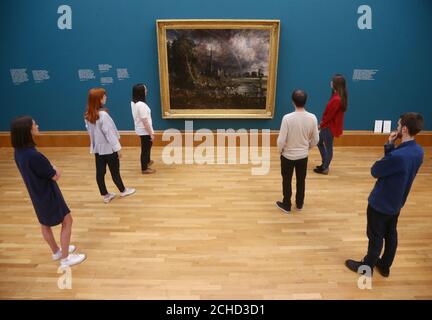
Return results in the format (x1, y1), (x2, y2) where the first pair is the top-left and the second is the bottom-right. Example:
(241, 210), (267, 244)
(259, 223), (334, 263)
(84, 111), (121, 155)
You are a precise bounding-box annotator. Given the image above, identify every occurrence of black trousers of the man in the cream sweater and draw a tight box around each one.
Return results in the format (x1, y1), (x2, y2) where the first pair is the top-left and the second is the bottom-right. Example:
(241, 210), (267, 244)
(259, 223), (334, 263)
(281, 156), (308, 208)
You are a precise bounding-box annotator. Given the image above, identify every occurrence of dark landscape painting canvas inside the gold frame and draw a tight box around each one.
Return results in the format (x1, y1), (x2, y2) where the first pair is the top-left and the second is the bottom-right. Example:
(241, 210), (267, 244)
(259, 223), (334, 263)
(166, 29), (270, 110)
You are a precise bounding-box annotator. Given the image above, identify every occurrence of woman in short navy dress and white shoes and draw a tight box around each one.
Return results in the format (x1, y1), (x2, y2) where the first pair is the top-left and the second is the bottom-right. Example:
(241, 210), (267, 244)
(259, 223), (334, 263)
(11, 116), (86, 267)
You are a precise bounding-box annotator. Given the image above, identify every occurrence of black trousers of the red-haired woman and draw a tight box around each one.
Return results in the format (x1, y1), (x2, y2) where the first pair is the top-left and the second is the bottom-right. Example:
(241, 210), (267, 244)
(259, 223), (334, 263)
(95, 152), (125, 196)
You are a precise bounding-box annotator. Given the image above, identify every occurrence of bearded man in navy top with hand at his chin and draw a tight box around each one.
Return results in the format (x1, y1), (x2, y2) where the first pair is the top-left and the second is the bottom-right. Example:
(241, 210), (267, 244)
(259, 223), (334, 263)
(345, 112), (424, 277)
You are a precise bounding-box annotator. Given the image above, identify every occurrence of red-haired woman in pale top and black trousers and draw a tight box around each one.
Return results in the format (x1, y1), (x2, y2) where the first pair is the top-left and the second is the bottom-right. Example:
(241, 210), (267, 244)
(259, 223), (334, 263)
(84, 88), (135, 203)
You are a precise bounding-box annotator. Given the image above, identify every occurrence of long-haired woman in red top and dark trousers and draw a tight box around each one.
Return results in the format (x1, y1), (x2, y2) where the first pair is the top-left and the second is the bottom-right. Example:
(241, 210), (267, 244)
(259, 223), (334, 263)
(314, 74), (348, 174)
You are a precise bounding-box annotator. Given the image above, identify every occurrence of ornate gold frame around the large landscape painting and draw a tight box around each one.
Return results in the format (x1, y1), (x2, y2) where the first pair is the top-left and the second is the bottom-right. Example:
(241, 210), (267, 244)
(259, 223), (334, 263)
(156, 20), (280, 119)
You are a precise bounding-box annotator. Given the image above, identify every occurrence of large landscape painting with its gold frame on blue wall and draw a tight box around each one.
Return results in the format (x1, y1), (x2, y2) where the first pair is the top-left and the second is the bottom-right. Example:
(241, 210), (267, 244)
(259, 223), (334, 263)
(156, 20), (280, 119)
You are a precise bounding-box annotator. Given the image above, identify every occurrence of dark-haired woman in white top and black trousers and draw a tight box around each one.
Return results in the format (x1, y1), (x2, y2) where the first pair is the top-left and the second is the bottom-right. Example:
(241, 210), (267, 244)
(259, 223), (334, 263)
(131, 83), (156, 174)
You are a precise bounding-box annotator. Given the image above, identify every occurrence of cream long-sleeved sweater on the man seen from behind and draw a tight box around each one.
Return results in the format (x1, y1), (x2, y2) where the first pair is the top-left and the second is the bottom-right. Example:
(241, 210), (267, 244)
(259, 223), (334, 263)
(277, 110), (319, 160)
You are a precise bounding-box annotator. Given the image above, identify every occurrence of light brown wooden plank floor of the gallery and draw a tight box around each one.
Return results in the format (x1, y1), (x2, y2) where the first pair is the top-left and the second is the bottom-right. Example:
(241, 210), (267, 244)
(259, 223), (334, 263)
(0, 147), (432, 299)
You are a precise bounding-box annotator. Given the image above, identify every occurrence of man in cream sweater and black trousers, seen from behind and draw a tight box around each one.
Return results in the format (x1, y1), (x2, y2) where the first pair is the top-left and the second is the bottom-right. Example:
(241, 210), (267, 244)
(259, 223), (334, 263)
(276, 89), (319, 213)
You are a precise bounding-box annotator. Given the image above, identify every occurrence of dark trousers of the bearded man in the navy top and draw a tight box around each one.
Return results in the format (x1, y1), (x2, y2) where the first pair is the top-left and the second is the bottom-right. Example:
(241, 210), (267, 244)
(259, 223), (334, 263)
(363, 205), (399, 269)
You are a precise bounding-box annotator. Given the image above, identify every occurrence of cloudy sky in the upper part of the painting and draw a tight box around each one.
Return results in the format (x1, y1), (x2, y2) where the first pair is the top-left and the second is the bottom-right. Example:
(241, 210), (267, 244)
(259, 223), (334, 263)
(166, 29), (270, 75)
